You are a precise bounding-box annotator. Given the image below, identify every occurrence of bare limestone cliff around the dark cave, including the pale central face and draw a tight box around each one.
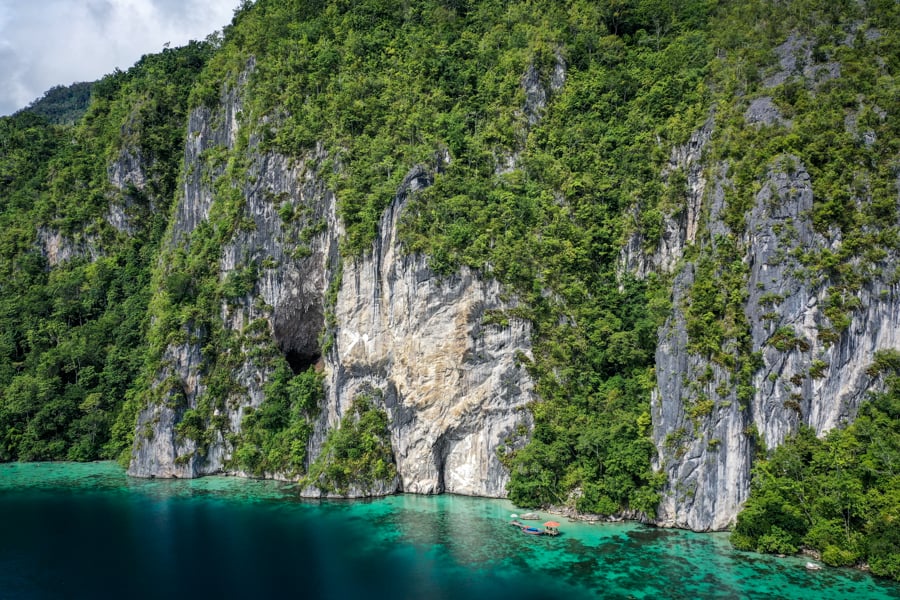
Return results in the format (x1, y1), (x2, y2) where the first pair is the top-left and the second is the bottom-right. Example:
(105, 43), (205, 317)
(129, 83), (534, 497)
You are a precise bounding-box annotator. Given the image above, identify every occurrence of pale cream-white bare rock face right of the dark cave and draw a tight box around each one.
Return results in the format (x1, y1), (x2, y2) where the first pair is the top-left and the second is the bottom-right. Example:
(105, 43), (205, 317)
(326, 169), (533, 496)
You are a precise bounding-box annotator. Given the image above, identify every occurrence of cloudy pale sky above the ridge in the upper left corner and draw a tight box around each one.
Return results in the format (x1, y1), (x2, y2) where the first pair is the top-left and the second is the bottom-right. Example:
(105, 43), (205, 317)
(0, 0), (239, 115)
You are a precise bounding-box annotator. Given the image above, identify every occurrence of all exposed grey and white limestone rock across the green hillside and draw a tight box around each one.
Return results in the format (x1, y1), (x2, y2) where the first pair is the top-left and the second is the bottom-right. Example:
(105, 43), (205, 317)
(123, 21), (900, 531)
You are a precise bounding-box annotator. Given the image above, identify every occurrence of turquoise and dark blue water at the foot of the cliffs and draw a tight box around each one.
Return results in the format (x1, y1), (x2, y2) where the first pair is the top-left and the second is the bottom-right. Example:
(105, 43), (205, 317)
(0, 463), (900, 600)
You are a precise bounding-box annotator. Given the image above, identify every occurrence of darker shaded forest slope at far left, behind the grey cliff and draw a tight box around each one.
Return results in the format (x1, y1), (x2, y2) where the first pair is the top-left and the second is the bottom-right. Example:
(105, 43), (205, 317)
(0, 43), (212, 460)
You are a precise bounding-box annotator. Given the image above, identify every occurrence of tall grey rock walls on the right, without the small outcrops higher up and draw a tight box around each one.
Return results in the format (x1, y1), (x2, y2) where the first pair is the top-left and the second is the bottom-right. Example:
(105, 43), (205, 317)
(652, 156), (900, 530)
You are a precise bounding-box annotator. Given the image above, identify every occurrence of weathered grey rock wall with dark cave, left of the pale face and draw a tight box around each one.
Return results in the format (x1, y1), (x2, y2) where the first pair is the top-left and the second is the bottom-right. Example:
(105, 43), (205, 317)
(129, 79), (340, 478)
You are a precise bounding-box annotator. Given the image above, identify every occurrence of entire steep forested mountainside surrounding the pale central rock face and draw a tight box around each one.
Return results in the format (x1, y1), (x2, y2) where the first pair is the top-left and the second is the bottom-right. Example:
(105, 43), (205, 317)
(0, 0), (900, 577)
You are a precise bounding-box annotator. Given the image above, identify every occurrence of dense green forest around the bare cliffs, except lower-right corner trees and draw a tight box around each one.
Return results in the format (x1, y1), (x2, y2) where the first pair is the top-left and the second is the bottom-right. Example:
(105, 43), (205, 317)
(0, 0), (900, 548)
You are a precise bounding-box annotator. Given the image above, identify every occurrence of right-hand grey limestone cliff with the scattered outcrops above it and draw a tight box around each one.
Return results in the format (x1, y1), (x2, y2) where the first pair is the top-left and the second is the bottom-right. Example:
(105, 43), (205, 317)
(619, 17), (900, 530)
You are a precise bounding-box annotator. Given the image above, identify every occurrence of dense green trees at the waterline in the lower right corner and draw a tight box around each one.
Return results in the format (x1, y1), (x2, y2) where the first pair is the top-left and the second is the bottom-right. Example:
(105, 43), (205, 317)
(731, 351), (900, 580)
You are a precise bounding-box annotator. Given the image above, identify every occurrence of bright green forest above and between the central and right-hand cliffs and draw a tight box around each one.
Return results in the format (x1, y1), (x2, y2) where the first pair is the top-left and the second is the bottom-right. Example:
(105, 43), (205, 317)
(202, 1), (897, 513)
